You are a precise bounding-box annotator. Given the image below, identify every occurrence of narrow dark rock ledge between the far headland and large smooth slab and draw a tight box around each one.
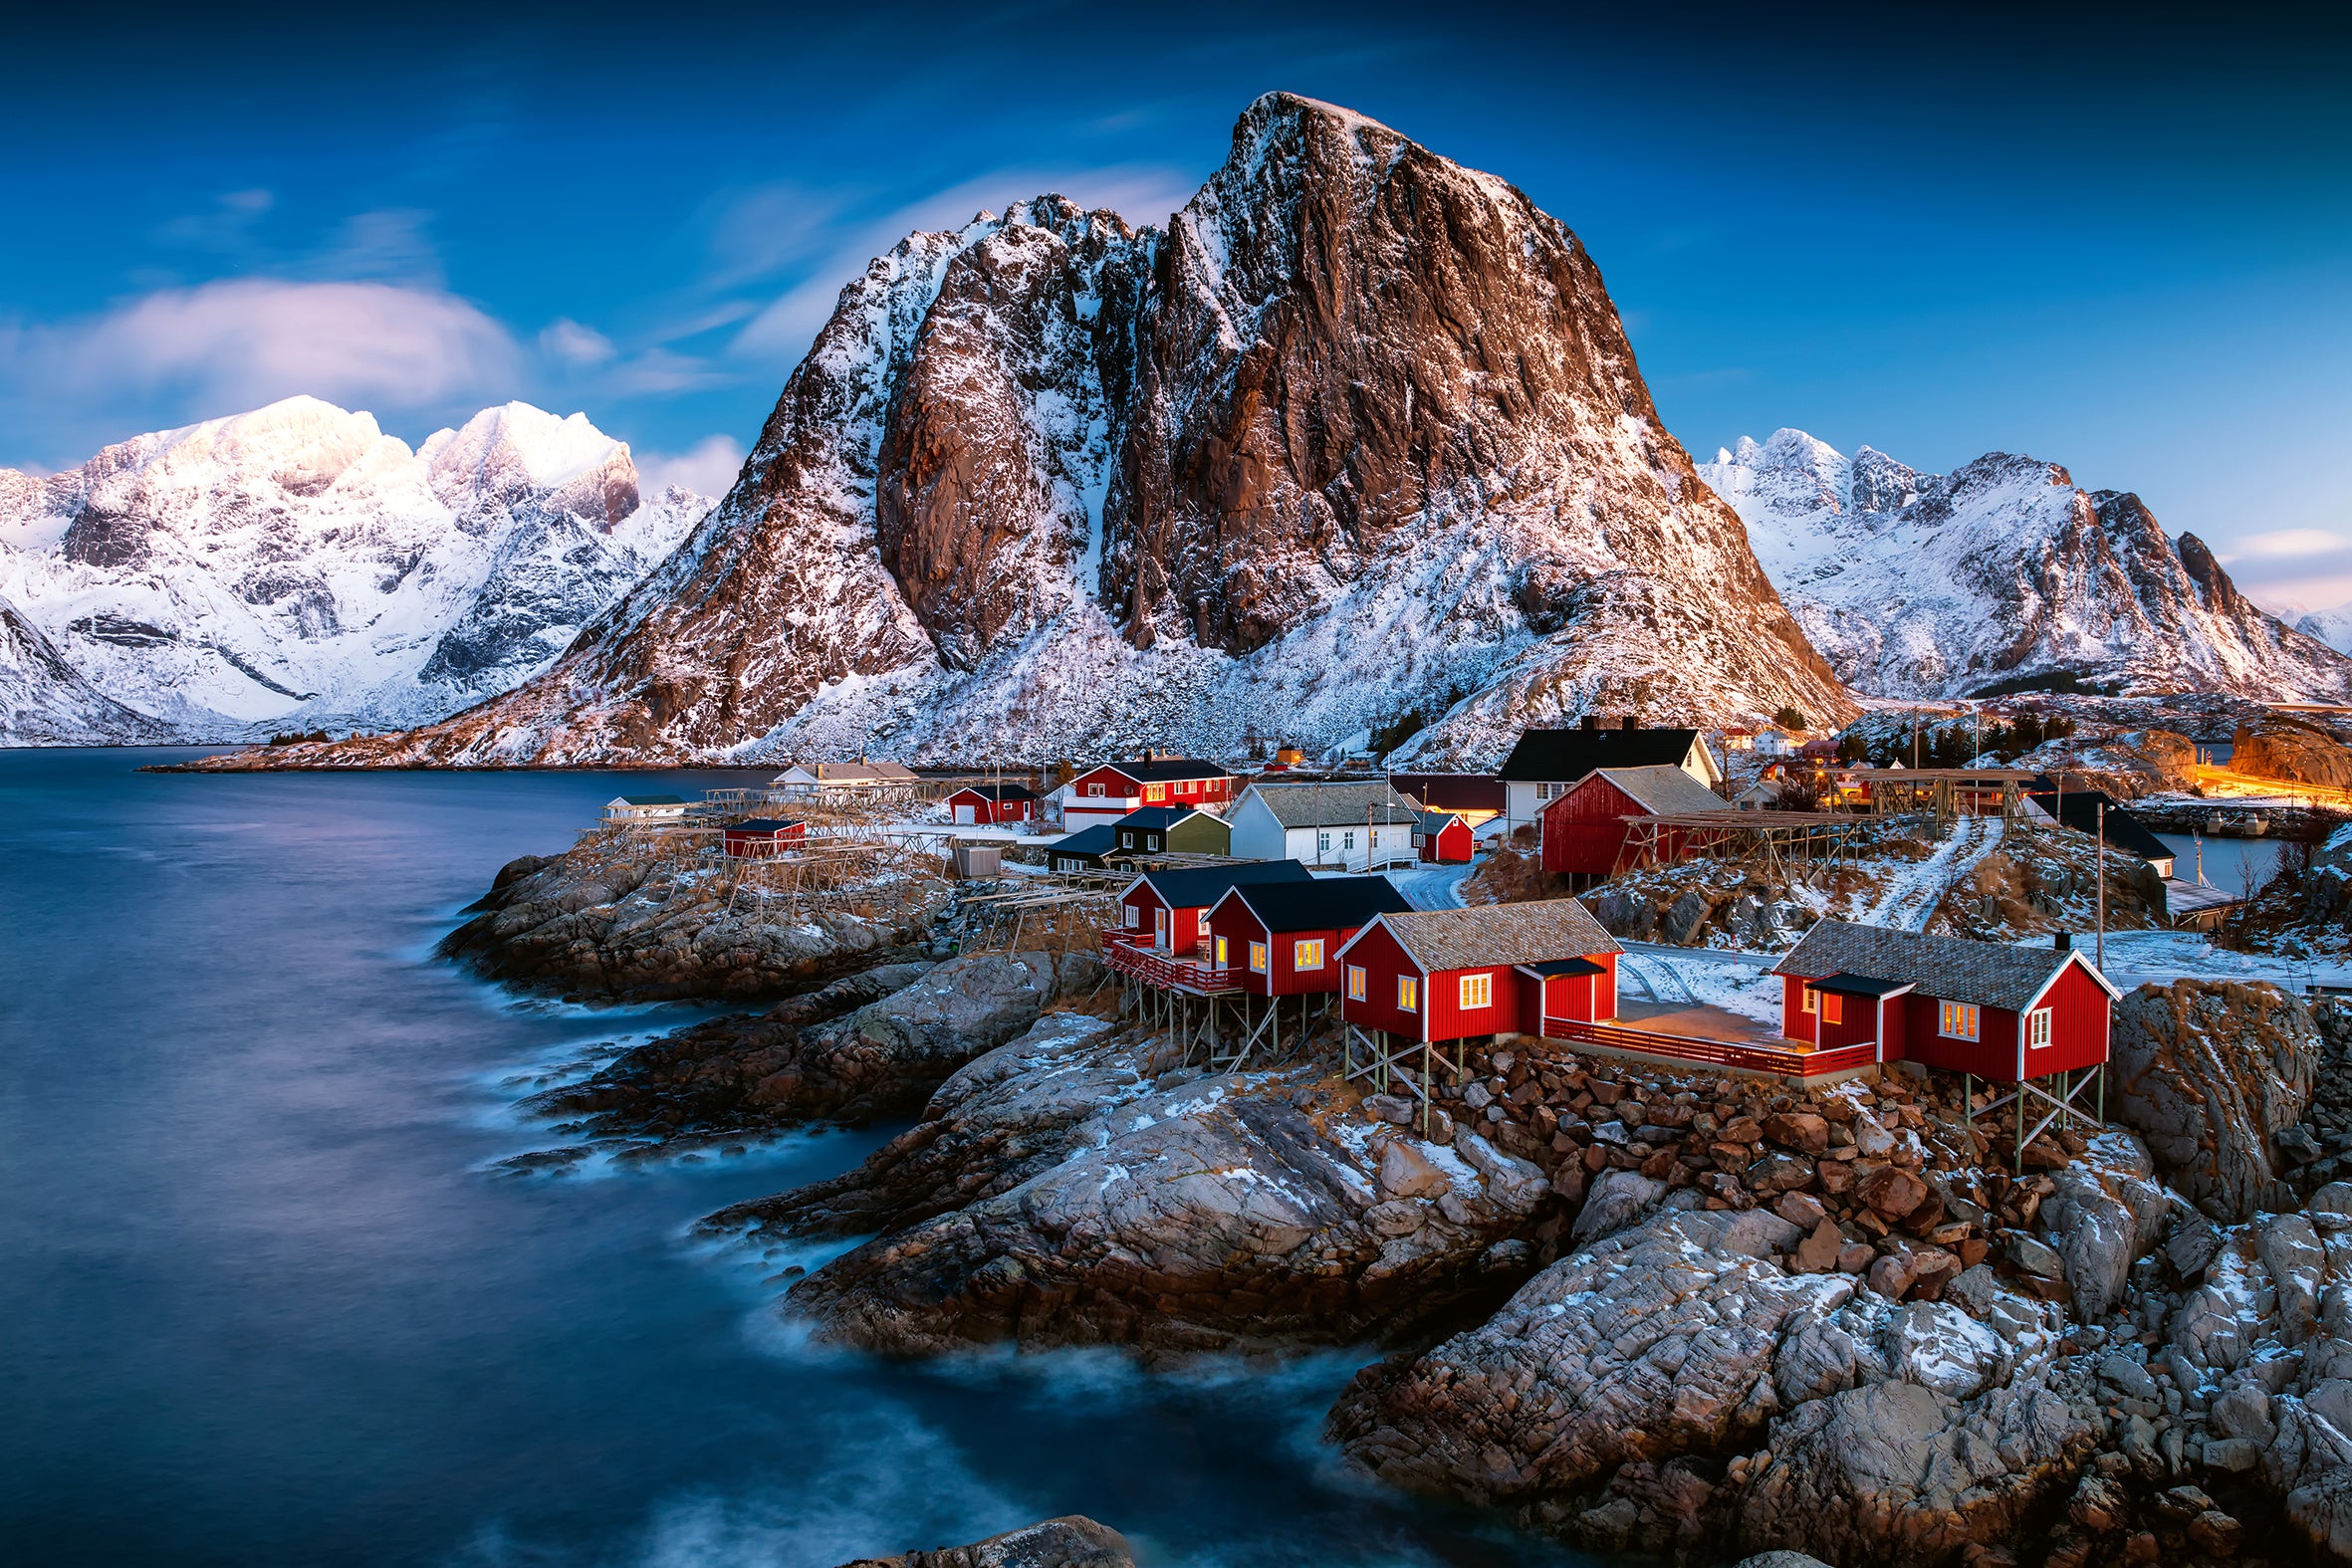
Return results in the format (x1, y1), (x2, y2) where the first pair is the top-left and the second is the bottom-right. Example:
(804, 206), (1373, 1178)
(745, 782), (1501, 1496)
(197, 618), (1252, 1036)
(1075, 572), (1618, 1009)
(522, 952), (1103, 1140)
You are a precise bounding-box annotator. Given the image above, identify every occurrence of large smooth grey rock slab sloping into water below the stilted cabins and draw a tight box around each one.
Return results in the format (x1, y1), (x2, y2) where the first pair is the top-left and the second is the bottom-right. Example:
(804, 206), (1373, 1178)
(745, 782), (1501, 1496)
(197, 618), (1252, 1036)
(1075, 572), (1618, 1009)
(786, 1060), (1557, 1356)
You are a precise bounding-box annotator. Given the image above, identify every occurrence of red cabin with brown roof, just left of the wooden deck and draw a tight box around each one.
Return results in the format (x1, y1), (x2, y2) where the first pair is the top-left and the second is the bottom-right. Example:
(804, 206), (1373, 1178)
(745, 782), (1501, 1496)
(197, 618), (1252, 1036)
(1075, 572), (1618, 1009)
(1340, 898), (1623, 1041)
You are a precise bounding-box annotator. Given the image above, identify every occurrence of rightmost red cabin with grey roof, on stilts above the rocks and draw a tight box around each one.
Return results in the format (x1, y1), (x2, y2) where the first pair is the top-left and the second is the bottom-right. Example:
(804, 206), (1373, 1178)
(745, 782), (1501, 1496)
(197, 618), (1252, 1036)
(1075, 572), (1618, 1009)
(1773, 919), (2122, 1084)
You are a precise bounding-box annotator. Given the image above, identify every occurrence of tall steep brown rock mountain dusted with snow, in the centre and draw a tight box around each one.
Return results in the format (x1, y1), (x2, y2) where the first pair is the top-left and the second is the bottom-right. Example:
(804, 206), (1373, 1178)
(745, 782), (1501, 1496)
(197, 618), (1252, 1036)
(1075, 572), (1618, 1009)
(270, 94), (1851, 764)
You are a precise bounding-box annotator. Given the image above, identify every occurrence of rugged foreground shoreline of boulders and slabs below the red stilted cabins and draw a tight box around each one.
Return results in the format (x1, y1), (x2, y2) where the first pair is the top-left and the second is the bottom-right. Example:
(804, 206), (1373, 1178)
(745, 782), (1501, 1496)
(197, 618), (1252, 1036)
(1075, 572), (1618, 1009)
(453, 841), (2352, 1568)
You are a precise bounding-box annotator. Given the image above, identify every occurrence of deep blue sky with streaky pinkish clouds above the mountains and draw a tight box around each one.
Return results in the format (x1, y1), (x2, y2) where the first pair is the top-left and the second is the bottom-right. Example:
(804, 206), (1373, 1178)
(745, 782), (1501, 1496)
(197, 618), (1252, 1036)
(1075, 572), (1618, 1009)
(13, 5), (2352, 606)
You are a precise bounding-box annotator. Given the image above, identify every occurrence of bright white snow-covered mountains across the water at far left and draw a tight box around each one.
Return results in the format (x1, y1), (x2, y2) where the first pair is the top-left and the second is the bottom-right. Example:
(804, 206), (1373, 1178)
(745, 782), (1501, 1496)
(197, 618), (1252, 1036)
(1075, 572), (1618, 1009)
(0, 397), (710, 741)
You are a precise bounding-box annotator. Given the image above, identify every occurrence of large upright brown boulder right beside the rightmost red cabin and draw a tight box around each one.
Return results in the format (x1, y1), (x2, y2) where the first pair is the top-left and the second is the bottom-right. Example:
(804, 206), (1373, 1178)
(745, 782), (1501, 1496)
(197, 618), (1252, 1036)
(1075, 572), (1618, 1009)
(2107, 981), (2319, 1221)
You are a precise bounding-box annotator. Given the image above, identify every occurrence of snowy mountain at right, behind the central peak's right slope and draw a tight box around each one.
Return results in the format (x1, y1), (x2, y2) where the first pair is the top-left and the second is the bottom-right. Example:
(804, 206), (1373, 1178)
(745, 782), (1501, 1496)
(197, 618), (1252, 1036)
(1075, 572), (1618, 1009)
(1698, 430), (2352, 701)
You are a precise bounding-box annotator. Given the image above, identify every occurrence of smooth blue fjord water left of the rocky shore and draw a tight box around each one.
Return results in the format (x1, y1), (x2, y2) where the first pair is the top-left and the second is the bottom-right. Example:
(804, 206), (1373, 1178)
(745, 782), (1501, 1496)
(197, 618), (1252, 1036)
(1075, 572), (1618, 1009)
(0, 750), (1568, 1568)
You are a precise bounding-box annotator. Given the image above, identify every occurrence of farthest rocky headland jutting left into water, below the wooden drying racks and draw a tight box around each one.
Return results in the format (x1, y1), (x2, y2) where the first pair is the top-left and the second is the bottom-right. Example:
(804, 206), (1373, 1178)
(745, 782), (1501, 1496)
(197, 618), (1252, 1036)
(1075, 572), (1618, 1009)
(440, 832), (948, 1002)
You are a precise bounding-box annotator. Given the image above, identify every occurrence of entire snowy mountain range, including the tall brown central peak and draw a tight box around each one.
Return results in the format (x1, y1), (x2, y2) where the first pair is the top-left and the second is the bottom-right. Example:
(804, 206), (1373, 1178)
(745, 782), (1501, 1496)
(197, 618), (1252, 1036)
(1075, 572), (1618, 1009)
(13, 94), (2352, 767)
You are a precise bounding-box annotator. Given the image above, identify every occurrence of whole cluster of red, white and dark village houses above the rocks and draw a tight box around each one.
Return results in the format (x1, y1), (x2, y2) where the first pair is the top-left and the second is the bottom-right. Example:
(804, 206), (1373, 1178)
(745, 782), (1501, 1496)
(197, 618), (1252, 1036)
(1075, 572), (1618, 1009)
(592, 717), (2171, 1145)
